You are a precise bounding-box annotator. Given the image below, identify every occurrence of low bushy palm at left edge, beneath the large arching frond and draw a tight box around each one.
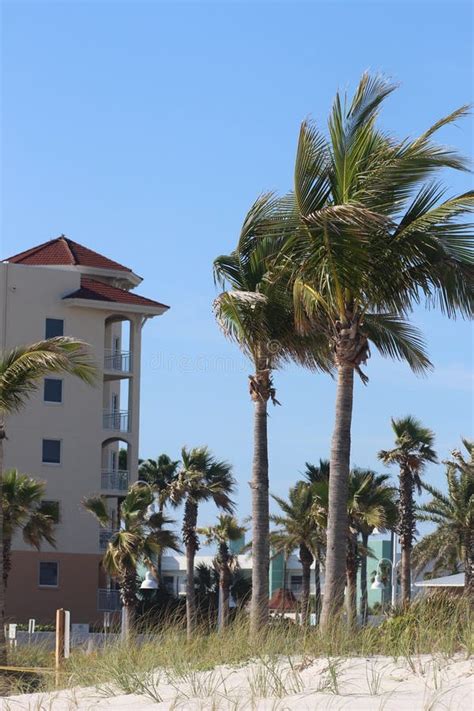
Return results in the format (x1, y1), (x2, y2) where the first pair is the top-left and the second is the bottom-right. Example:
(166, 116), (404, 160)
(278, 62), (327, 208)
(2, 469), (58, 588)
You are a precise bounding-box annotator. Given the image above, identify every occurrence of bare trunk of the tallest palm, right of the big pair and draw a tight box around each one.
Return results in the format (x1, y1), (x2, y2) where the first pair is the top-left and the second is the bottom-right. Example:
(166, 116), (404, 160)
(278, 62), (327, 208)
(321, 365), (354, 629)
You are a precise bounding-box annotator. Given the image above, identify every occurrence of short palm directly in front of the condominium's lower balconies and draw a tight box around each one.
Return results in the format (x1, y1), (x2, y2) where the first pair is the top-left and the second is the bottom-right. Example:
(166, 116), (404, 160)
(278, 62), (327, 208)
(82, 484), (179, 637)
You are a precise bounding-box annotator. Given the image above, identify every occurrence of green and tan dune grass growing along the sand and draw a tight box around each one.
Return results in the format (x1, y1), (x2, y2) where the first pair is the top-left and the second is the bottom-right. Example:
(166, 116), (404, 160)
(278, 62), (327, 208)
(2, 595), (473, 702)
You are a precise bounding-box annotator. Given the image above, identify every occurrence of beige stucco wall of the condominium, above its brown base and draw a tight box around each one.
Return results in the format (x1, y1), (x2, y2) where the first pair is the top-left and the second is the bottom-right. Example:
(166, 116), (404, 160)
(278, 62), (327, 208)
(0, 264), (141, 560)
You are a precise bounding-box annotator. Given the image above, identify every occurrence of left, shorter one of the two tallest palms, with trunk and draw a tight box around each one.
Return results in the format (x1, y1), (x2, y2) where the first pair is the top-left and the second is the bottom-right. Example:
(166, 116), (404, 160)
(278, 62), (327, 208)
(214, 194), (329, 634)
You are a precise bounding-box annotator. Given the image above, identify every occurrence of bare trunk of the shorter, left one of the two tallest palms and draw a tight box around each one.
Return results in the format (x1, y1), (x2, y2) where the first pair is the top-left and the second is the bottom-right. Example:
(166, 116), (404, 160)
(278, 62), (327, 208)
(250, 395), (270, 635)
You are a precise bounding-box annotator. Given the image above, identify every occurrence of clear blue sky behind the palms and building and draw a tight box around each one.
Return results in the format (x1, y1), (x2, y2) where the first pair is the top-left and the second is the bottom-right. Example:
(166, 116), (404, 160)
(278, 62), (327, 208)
(2, 0), (472, 523)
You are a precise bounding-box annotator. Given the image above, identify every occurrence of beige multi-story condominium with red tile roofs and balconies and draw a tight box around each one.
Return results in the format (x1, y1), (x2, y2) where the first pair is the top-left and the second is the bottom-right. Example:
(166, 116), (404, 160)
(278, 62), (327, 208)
(0, 236), (168, 622)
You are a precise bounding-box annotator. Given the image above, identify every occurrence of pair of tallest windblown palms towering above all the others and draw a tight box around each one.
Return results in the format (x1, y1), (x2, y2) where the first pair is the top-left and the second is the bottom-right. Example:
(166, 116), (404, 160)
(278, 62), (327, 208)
(214, 75), (473, 632)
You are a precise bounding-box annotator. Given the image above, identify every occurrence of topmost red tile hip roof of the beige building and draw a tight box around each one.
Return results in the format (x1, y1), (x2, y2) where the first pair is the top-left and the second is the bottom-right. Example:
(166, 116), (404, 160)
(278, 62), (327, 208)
(3, 235), (132, 272)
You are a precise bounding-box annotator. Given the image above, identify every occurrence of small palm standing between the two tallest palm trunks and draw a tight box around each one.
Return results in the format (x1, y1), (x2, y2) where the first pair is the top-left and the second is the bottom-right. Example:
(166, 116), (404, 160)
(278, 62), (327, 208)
(270, 481), (325, 624)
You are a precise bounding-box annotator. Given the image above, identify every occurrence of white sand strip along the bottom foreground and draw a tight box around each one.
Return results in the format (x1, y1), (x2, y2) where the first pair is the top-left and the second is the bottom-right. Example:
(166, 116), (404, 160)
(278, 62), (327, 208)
(0, 655), (474, 711)
